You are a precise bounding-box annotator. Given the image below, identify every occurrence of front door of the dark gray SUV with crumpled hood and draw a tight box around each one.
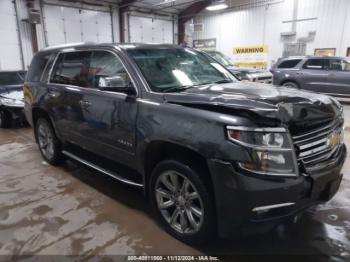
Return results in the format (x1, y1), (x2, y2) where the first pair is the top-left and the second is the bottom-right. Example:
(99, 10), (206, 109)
(79, 51), (138, 162)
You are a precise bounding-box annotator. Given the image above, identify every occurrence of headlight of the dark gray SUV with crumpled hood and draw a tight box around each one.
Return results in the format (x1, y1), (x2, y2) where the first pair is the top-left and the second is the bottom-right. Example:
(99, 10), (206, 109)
(227, 127), (298, 176)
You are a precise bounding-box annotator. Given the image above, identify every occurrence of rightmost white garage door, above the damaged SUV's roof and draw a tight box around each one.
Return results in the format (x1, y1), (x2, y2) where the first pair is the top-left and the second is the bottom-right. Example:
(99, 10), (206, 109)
(129, 15), (173, 44)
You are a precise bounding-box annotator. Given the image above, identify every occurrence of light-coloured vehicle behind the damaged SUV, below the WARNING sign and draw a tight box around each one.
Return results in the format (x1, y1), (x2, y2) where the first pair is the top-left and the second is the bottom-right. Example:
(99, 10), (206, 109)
(205, 51), (272, 84)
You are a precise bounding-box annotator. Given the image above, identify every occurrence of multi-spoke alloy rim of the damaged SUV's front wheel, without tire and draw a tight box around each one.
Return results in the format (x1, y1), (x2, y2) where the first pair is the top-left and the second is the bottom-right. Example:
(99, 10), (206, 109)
(155, 171), (204, 234)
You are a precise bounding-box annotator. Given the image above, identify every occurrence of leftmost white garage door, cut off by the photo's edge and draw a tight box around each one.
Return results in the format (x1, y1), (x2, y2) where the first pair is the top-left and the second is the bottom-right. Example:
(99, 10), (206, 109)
(0, 0), (22, 70)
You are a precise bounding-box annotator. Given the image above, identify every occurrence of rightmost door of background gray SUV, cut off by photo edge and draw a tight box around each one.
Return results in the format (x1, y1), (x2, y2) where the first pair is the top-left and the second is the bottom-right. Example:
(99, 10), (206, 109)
(326, 58), (350, 97)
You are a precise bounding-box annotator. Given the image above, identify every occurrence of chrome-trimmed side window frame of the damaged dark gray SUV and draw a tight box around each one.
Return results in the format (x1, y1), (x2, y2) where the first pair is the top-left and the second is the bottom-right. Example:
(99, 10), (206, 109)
(47, 48), (140, 97)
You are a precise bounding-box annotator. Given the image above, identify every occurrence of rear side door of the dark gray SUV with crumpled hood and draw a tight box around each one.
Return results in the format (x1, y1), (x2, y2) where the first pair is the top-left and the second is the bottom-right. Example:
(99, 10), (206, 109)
(48, 51), (92, 145)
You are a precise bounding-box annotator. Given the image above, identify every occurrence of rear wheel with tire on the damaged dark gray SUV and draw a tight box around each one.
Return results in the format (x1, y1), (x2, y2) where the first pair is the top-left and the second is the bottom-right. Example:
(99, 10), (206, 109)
(35, 118), (64, 165)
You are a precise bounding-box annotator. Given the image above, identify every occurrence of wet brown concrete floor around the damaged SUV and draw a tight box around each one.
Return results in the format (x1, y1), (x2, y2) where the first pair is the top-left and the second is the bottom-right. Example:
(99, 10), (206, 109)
(0, 106), (350, 261)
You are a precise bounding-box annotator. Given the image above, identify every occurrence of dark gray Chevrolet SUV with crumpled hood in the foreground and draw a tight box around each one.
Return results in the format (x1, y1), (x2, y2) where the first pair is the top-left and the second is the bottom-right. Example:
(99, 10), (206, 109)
(24, 44), (346, 243)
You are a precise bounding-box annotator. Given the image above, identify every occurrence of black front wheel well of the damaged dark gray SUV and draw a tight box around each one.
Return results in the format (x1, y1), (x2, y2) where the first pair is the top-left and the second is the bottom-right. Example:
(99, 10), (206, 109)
(144, 141), (214, 193)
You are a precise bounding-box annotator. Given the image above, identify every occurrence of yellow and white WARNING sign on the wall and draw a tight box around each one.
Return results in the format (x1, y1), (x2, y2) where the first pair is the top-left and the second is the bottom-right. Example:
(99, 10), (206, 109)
(232, 45), (269, 69)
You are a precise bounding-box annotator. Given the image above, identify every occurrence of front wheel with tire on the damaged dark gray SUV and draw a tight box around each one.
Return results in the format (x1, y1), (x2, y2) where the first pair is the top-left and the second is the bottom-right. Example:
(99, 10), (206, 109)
(149, 160), (216, 245)
